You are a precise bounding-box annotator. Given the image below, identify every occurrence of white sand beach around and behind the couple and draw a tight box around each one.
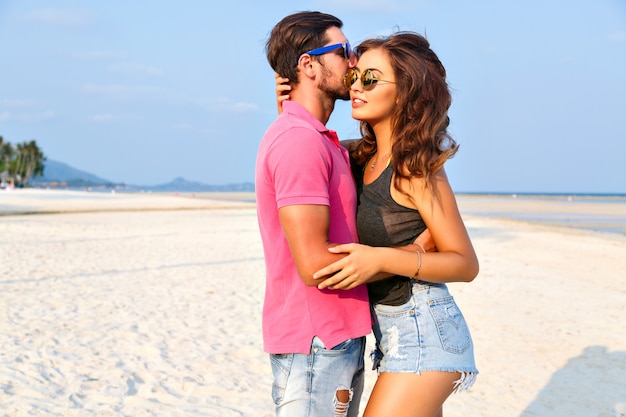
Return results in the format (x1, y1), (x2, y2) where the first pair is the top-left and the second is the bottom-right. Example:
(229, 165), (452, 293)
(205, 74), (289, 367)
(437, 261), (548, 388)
(0, 190), (626, 417)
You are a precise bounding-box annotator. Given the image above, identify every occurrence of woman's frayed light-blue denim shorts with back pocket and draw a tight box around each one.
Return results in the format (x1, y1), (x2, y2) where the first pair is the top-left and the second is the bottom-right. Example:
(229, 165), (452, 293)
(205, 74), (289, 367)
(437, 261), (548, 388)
(371, 281), (478, 391)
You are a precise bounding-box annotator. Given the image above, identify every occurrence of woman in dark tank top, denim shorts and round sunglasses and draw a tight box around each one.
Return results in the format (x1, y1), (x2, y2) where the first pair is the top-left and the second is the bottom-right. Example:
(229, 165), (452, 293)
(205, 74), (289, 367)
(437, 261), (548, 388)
(277, 32), (478, 417)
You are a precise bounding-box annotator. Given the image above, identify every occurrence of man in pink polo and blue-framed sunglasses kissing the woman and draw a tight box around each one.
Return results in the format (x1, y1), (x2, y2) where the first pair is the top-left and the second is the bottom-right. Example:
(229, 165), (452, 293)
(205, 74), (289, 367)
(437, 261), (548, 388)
(256, 12), (371, 417)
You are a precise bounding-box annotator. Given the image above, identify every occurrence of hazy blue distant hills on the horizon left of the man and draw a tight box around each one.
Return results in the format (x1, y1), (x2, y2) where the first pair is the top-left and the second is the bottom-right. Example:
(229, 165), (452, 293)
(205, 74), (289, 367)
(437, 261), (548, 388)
(31, 159), (254, 192)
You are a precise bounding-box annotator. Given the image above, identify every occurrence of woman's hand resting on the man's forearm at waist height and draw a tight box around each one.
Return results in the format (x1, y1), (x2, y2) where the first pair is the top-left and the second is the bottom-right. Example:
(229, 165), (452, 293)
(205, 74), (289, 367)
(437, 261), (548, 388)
(313, 243), (380, 290)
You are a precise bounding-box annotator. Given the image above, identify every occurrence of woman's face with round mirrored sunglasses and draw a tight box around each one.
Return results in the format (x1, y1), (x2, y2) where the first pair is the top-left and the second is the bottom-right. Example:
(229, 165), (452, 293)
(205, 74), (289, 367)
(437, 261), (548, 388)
(349, 49), (398, 126)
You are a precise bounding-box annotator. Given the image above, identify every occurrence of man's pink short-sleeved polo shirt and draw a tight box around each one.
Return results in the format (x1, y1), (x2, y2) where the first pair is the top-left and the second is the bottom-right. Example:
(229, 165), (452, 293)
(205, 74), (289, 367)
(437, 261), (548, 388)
(255, 101), (372, 354)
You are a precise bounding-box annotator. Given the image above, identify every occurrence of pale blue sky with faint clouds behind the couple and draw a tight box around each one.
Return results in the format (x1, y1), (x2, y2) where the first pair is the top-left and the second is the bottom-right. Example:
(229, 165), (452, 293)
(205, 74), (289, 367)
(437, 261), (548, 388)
(0, 0), (626, 194)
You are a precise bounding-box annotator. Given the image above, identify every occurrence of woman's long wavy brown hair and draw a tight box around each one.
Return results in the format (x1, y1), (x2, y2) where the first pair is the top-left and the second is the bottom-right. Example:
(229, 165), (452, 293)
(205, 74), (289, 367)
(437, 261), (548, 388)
(352, 32), (459, 189)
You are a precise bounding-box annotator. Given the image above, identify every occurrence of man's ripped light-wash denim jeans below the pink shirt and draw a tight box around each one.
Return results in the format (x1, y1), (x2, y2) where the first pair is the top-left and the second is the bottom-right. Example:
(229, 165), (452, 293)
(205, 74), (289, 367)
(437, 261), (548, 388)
(270, 336), (365, 417)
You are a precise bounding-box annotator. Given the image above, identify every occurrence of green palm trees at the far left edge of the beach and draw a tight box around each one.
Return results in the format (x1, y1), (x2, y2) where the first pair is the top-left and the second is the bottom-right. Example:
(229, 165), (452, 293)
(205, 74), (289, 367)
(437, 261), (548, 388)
(0, 136), (46, 187)
